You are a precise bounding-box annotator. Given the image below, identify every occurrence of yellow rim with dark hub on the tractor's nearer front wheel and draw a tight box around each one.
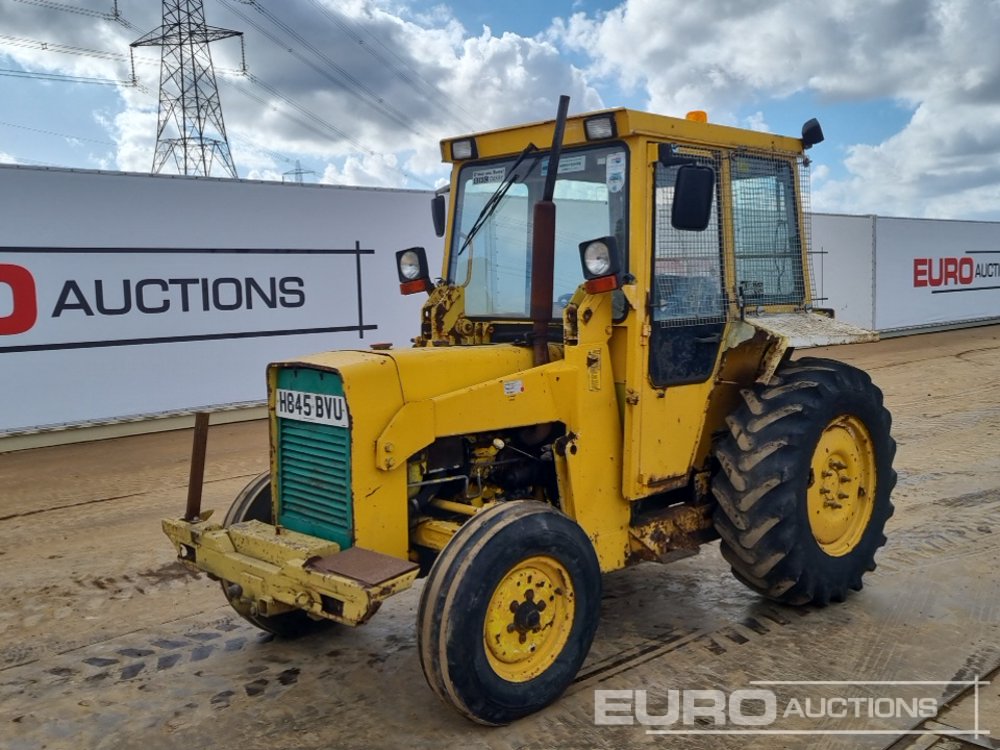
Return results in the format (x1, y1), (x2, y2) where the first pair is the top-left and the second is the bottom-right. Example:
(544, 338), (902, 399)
(483, 555), (576, 682)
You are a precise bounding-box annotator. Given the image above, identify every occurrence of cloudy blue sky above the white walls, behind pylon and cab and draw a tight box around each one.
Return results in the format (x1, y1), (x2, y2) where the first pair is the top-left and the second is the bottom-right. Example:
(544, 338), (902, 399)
(0, 0), (1000, 221)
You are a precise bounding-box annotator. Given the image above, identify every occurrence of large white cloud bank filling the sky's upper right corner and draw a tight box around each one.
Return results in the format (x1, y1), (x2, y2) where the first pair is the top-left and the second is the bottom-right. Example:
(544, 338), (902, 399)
(548, 0), (1000, 218)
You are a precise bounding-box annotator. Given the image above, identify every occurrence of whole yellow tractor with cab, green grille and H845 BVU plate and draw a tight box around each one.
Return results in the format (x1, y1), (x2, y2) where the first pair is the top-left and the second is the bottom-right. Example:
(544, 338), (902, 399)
(163, 97), (895, 724)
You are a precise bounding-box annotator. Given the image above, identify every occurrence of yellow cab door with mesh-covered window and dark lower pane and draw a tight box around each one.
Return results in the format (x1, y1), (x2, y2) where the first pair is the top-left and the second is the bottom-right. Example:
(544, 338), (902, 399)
(623, 148), (728, 499)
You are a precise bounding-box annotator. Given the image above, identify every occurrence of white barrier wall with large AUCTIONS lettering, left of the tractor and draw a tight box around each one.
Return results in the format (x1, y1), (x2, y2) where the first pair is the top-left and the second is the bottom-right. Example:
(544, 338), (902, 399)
(0, 166), (441, 435)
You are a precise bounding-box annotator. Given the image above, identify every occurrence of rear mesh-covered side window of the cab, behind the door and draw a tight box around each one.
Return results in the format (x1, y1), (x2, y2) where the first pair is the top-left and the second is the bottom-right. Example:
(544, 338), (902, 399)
(731, 154), (805, 306)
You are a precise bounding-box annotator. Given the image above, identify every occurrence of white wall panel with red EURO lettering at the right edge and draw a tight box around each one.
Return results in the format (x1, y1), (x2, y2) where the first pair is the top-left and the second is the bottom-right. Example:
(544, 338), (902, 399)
(875, 217), (1000, 331)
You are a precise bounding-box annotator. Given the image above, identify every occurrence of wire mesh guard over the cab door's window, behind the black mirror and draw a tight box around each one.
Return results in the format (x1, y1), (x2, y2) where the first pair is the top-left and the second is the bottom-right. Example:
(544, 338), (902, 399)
(652, 150), (726, 326)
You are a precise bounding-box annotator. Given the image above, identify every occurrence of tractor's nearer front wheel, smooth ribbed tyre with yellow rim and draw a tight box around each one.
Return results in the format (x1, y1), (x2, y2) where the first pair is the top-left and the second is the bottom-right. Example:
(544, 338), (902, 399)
(417, 500), (601, 725)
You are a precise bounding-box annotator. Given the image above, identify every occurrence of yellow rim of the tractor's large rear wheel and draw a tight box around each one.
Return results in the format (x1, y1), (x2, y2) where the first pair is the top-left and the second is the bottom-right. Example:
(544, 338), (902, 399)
(807, 414), (875, 557)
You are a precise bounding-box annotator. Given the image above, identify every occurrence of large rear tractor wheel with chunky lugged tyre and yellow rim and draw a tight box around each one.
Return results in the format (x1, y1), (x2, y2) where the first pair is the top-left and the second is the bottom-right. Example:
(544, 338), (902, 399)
(712, 357), (896, 604)
